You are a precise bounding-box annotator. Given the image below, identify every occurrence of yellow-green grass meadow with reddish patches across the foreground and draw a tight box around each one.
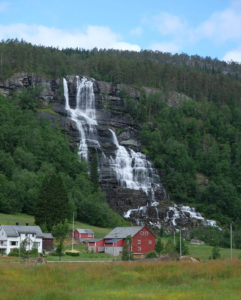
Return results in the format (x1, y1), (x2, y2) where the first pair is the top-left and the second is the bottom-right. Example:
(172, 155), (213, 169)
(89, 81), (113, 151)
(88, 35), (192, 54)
(0, 260), (241, 300)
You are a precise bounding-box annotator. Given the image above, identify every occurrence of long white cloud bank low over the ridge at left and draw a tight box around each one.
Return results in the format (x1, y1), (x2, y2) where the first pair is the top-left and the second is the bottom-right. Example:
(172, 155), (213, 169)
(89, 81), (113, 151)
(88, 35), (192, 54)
(0, 24), (140, 51)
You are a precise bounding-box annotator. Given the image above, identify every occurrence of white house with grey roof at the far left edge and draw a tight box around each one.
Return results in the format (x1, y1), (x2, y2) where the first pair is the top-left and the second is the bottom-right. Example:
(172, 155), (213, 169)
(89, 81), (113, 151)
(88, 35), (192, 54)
(0, 225), (43, 254)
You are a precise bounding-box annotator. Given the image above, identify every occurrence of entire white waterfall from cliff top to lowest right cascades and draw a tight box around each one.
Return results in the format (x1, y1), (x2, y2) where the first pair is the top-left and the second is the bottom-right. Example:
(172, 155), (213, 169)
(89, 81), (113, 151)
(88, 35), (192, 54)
(63, 76), (216, 227)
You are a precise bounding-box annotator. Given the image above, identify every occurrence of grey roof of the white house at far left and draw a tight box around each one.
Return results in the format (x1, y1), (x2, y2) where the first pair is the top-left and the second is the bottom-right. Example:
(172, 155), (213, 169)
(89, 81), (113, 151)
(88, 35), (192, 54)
(1, 225), (43, 237)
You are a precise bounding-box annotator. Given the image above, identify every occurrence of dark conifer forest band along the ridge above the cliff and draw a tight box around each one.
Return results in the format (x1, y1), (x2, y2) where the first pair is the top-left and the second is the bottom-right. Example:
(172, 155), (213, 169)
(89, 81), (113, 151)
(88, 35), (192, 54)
(0, 40), (241, 104)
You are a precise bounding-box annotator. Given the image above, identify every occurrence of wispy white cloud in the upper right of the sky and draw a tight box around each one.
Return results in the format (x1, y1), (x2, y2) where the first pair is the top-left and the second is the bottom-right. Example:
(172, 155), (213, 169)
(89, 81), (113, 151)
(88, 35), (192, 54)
(145, 0), (241, 55)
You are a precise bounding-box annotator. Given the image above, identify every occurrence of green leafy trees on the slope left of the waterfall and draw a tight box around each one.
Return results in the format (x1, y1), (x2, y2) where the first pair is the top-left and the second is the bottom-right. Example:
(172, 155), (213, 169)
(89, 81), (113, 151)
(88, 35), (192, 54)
(0, 89), (122, 226)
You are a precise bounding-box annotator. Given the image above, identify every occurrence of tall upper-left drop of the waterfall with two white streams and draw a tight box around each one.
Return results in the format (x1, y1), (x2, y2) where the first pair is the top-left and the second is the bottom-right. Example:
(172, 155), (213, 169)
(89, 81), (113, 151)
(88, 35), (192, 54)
(63, 76), (99, 161)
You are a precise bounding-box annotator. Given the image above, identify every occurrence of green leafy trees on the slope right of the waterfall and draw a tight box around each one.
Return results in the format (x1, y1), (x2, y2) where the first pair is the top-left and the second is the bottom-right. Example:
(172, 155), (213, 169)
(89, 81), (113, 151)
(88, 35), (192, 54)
(126, 93), (241, 225)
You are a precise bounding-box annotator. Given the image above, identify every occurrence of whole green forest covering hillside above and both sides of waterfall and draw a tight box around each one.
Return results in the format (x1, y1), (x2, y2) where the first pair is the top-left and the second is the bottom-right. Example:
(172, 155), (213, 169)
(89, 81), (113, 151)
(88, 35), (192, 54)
(0, 40), (241, 227)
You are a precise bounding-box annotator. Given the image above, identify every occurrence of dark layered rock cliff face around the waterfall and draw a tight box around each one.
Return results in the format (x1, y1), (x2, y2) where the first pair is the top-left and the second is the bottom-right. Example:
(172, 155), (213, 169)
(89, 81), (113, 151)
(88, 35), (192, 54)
(0, 73), (218, 231)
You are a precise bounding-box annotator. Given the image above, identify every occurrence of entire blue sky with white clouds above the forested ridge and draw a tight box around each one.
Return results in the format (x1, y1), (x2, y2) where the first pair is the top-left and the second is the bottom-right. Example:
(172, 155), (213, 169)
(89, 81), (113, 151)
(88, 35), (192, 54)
(0, 0), (241, 63)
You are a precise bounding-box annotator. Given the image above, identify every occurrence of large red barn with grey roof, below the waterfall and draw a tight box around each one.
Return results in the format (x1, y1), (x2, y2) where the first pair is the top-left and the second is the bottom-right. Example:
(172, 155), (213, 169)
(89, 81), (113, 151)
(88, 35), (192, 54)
(104, 226), (156, 256)
